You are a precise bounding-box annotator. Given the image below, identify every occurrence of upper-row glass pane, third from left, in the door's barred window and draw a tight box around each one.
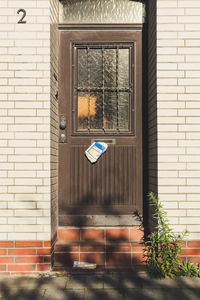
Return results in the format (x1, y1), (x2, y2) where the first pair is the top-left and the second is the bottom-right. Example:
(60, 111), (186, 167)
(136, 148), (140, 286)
(104, 49), (116, 87)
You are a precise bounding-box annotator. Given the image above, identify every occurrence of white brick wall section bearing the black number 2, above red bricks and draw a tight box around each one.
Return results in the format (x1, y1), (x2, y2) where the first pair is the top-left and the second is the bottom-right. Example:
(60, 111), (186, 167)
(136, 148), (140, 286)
(0, 0), (58, 240)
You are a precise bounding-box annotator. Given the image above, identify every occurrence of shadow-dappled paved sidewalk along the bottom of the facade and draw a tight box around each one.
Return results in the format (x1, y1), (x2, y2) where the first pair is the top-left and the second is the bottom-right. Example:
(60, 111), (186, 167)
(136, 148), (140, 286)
(0, 273), (200, 300)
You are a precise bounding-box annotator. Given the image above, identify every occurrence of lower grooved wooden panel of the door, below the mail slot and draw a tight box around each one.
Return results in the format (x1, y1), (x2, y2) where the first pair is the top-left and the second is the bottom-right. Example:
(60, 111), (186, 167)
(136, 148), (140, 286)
(60, 146), (136, 214)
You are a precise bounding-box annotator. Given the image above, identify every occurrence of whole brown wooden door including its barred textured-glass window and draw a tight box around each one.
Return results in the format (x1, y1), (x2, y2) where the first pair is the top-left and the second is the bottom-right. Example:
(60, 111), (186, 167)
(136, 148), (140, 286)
(59, 29), (142, 225)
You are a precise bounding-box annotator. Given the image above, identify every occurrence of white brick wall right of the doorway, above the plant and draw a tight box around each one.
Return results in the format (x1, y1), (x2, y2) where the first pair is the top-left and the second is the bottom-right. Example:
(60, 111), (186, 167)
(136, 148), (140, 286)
(157, 0), (200, 239)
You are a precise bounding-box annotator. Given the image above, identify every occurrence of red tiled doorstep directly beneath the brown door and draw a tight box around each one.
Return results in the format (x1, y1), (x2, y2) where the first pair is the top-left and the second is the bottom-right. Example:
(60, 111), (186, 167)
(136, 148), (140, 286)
(54, 228), (144, 270)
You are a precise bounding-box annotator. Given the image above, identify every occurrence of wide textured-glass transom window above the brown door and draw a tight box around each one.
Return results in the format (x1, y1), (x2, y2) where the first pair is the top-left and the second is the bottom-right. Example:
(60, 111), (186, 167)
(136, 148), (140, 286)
(59, 0), (144, 24)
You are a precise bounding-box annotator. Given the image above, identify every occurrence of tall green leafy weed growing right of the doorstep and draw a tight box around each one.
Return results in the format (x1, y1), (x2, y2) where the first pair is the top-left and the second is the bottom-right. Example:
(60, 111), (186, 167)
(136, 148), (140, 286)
(145, 192), (187, 278)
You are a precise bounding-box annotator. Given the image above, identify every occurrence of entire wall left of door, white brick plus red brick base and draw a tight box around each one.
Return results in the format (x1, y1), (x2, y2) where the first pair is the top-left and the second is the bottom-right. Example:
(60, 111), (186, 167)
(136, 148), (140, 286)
(0, 0), (58, 274)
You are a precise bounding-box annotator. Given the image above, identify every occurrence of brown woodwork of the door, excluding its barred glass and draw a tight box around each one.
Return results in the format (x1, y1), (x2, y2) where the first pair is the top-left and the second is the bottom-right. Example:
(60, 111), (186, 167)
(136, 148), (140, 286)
(59, 30), (142, 221)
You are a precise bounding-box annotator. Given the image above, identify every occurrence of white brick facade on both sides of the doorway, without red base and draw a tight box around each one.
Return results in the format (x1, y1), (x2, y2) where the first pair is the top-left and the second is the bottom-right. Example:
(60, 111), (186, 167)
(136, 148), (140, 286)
(0, 0), (200, 240)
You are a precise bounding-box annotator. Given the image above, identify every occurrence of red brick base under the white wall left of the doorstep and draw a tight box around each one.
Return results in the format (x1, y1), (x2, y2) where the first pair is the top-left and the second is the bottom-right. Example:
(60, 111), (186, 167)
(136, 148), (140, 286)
(0, 241), (51, 275)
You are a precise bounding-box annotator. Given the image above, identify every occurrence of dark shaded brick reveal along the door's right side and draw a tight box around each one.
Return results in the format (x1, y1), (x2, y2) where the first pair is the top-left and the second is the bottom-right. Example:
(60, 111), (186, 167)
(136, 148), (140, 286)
(143, 0), (158, 235)
